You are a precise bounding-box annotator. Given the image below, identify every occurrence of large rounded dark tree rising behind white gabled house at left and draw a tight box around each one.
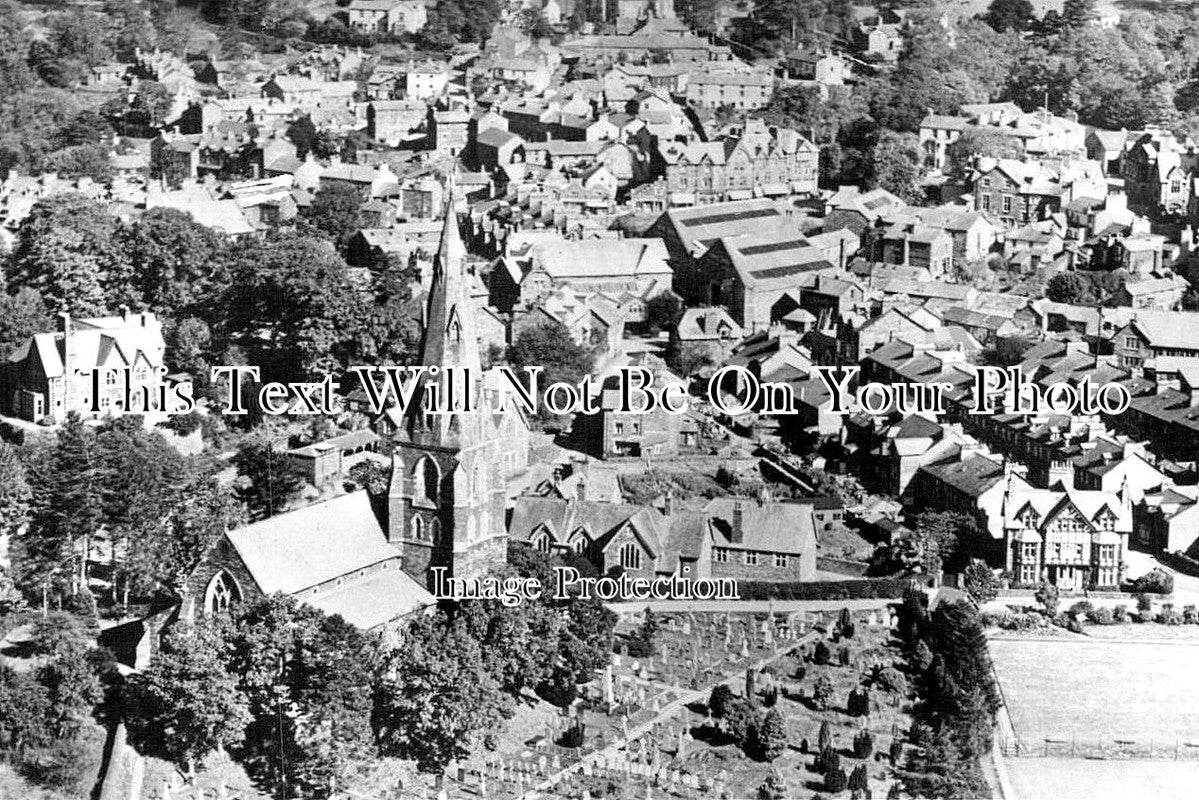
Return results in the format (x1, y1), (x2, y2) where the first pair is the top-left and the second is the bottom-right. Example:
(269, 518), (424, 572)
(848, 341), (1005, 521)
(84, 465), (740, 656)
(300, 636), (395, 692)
(8, 193), (137, 317)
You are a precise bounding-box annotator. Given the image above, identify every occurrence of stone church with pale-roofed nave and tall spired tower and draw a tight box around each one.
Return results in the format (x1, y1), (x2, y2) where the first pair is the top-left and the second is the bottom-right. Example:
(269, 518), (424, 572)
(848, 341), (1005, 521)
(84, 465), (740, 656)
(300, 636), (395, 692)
(180, 183), (529, 631)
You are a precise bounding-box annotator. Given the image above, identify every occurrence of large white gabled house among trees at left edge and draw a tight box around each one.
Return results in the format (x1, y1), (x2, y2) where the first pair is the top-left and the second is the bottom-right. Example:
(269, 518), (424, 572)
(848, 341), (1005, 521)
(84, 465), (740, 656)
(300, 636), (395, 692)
(0, 311), (191, 422)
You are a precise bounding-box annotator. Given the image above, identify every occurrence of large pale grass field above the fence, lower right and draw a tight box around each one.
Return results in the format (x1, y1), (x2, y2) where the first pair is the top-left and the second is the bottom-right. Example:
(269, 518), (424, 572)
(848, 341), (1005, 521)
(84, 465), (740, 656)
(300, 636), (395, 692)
(990, 639), (1199, 743)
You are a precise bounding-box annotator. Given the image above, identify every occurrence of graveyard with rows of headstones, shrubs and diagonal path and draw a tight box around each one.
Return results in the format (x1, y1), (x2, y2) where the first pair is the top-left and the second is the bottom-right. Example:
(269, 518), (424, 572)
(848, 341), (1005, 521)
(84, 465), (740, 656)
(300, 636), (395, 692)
(436, 601), (910, 800)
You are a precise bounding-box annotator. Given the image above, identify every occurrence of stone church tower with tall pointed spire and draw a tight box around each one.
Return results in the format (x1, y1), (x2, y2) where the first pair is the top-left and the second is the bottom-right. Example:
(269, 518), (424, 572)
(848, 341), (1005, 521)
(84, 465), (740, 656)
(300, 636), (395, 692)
(387, 185), (529, 587)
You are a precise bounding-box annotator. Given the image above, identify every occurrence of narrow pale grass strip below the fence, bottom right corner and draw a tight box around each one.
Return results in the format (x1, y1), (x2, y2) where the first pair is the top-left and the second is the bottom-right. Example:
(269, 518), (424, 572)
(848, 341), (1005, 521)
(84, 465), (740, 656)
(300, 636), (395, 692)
(1004, 758), (1199, 800)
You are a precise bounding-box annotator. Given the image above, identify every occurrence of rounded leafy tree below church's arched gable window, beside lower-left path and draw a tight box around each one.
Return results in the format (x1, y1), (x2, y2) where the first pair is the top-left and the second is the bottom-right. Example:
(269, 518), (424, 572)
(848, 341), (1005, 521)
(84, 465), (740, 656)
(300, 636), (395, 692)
(123, 626), (251, 774)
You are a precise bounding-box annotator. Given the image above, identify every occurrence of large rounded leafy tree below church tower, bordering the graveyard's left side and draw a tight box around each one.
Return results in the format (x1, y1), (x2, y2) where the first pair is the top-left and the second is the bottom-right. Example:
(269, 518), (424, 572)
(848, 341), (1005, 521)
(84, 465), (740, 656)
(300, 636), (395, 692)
(374, 609), (511, 771)
